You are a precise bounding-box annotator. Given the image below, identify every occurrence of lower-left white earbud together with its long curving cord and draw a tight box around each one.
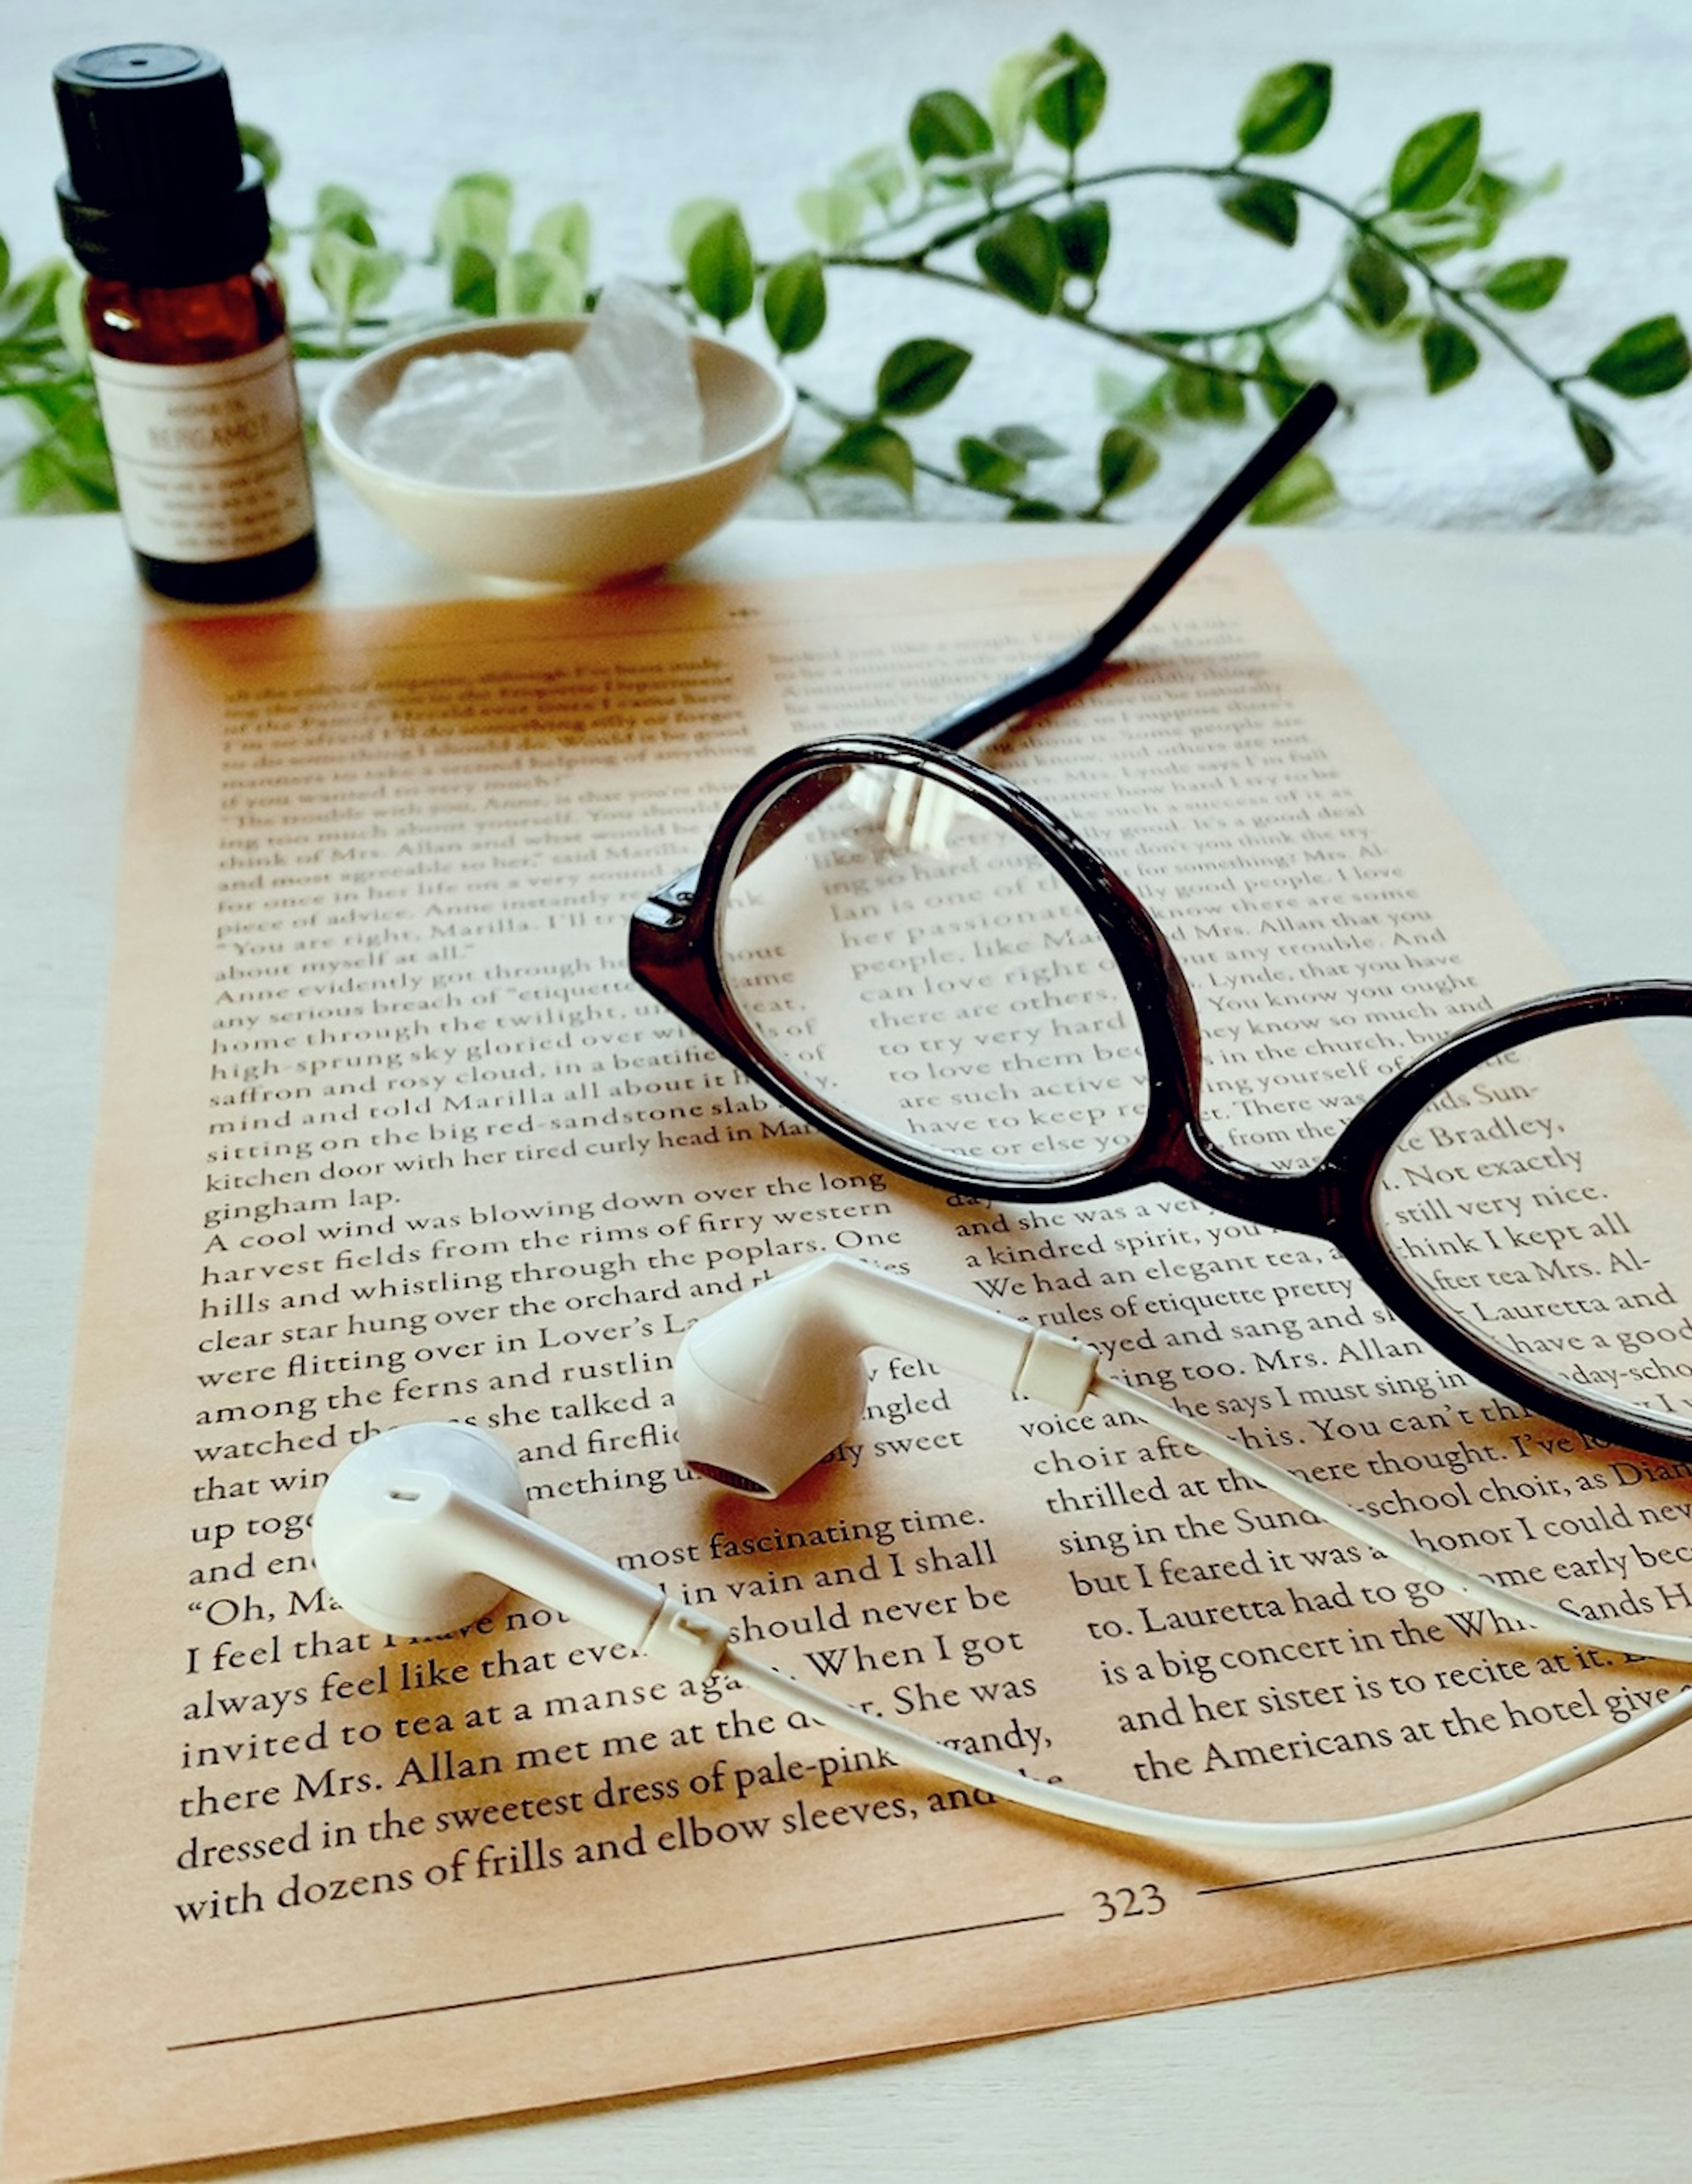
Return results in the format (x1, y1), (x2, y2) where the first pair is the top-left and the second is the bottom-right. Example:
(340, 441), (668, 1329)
(312, 1424), (1692, 1850)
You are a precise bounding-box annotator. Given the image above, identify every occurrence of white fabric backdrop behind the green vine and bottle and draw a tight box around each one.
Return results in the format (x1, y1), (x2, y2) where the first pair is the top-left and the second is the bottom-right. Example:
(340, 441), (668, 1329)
(0, 0), (1692, 531)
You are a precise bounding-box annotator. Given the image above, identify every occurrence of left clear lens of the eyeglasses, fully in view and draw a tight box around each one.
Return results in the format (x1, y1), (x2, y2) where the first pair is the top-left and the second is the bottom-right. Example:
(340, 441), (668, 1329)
(716, 766), (1146, 1188)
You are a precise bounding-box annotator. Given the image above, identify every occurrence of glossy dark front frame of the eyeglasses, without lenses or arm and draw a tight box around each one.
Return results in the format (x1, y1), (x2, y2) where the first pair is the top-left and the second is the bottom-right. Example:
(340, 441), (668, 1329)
(629, 736), (1692, 1459)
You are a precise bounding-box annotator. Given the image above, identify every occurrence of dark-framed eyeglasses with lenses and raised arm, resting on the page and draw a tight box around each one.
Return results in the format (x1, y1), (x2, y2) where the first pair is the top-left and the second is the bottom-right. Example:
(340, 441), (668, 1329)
(629, 400), (1692, 1457)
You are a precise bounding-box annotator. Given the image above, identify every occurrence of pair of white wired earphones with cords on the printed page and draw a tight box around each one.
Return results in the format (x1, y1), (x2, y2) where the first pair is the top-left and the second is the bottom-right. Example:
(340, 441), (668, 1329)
(312, 1258), (1692, 1850)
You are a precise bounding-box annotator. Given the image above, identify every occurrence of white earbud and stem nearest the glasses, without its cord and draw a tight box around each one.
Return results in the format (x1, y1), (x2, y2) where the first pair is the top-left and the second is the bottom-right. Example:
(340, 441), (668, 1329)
(675, 1258), (1098, 1496)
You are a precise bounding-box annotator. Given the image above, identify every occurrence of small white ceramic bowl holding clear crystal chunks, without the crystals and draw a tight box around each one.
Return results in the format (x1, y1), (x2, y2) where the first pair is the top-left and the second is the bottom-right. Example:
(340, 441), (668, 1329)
(319, 319), (795, 585)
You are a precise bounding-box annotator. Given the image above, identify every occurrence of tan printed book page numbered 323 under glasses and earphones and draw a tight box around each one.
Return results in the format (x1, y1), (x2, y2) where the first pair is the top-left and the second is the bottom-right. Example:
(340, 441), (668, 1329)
(7, 555), (1692, 2177)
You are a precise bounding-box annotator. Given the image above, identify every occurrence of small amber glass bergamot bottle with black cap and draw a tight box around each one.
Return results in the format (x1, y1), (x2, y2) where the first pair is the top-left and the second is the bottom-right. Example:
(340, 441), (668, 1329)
(55, 46), (316, 600)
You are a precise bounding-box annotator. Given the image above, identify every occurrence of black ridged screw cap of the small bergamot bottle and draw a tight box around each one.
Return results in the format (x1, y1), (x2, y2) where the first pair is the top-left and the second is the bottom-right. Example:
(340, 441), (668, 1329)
(52, 46), (271, 288)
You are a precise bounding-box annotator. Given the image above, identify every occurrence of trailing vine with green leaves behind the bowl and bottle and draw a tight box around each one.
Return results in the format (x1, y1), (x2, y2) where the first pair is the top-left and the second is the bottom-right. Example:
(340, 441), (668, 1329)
(0, 33), (1692, 522)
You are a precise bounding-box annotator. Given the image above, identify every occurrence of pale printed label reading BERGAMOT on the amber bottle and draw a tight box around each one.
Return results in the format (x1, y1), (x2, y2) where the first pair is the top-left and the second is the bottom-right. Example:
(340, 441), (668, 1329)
(89, 337), (314, 561)
